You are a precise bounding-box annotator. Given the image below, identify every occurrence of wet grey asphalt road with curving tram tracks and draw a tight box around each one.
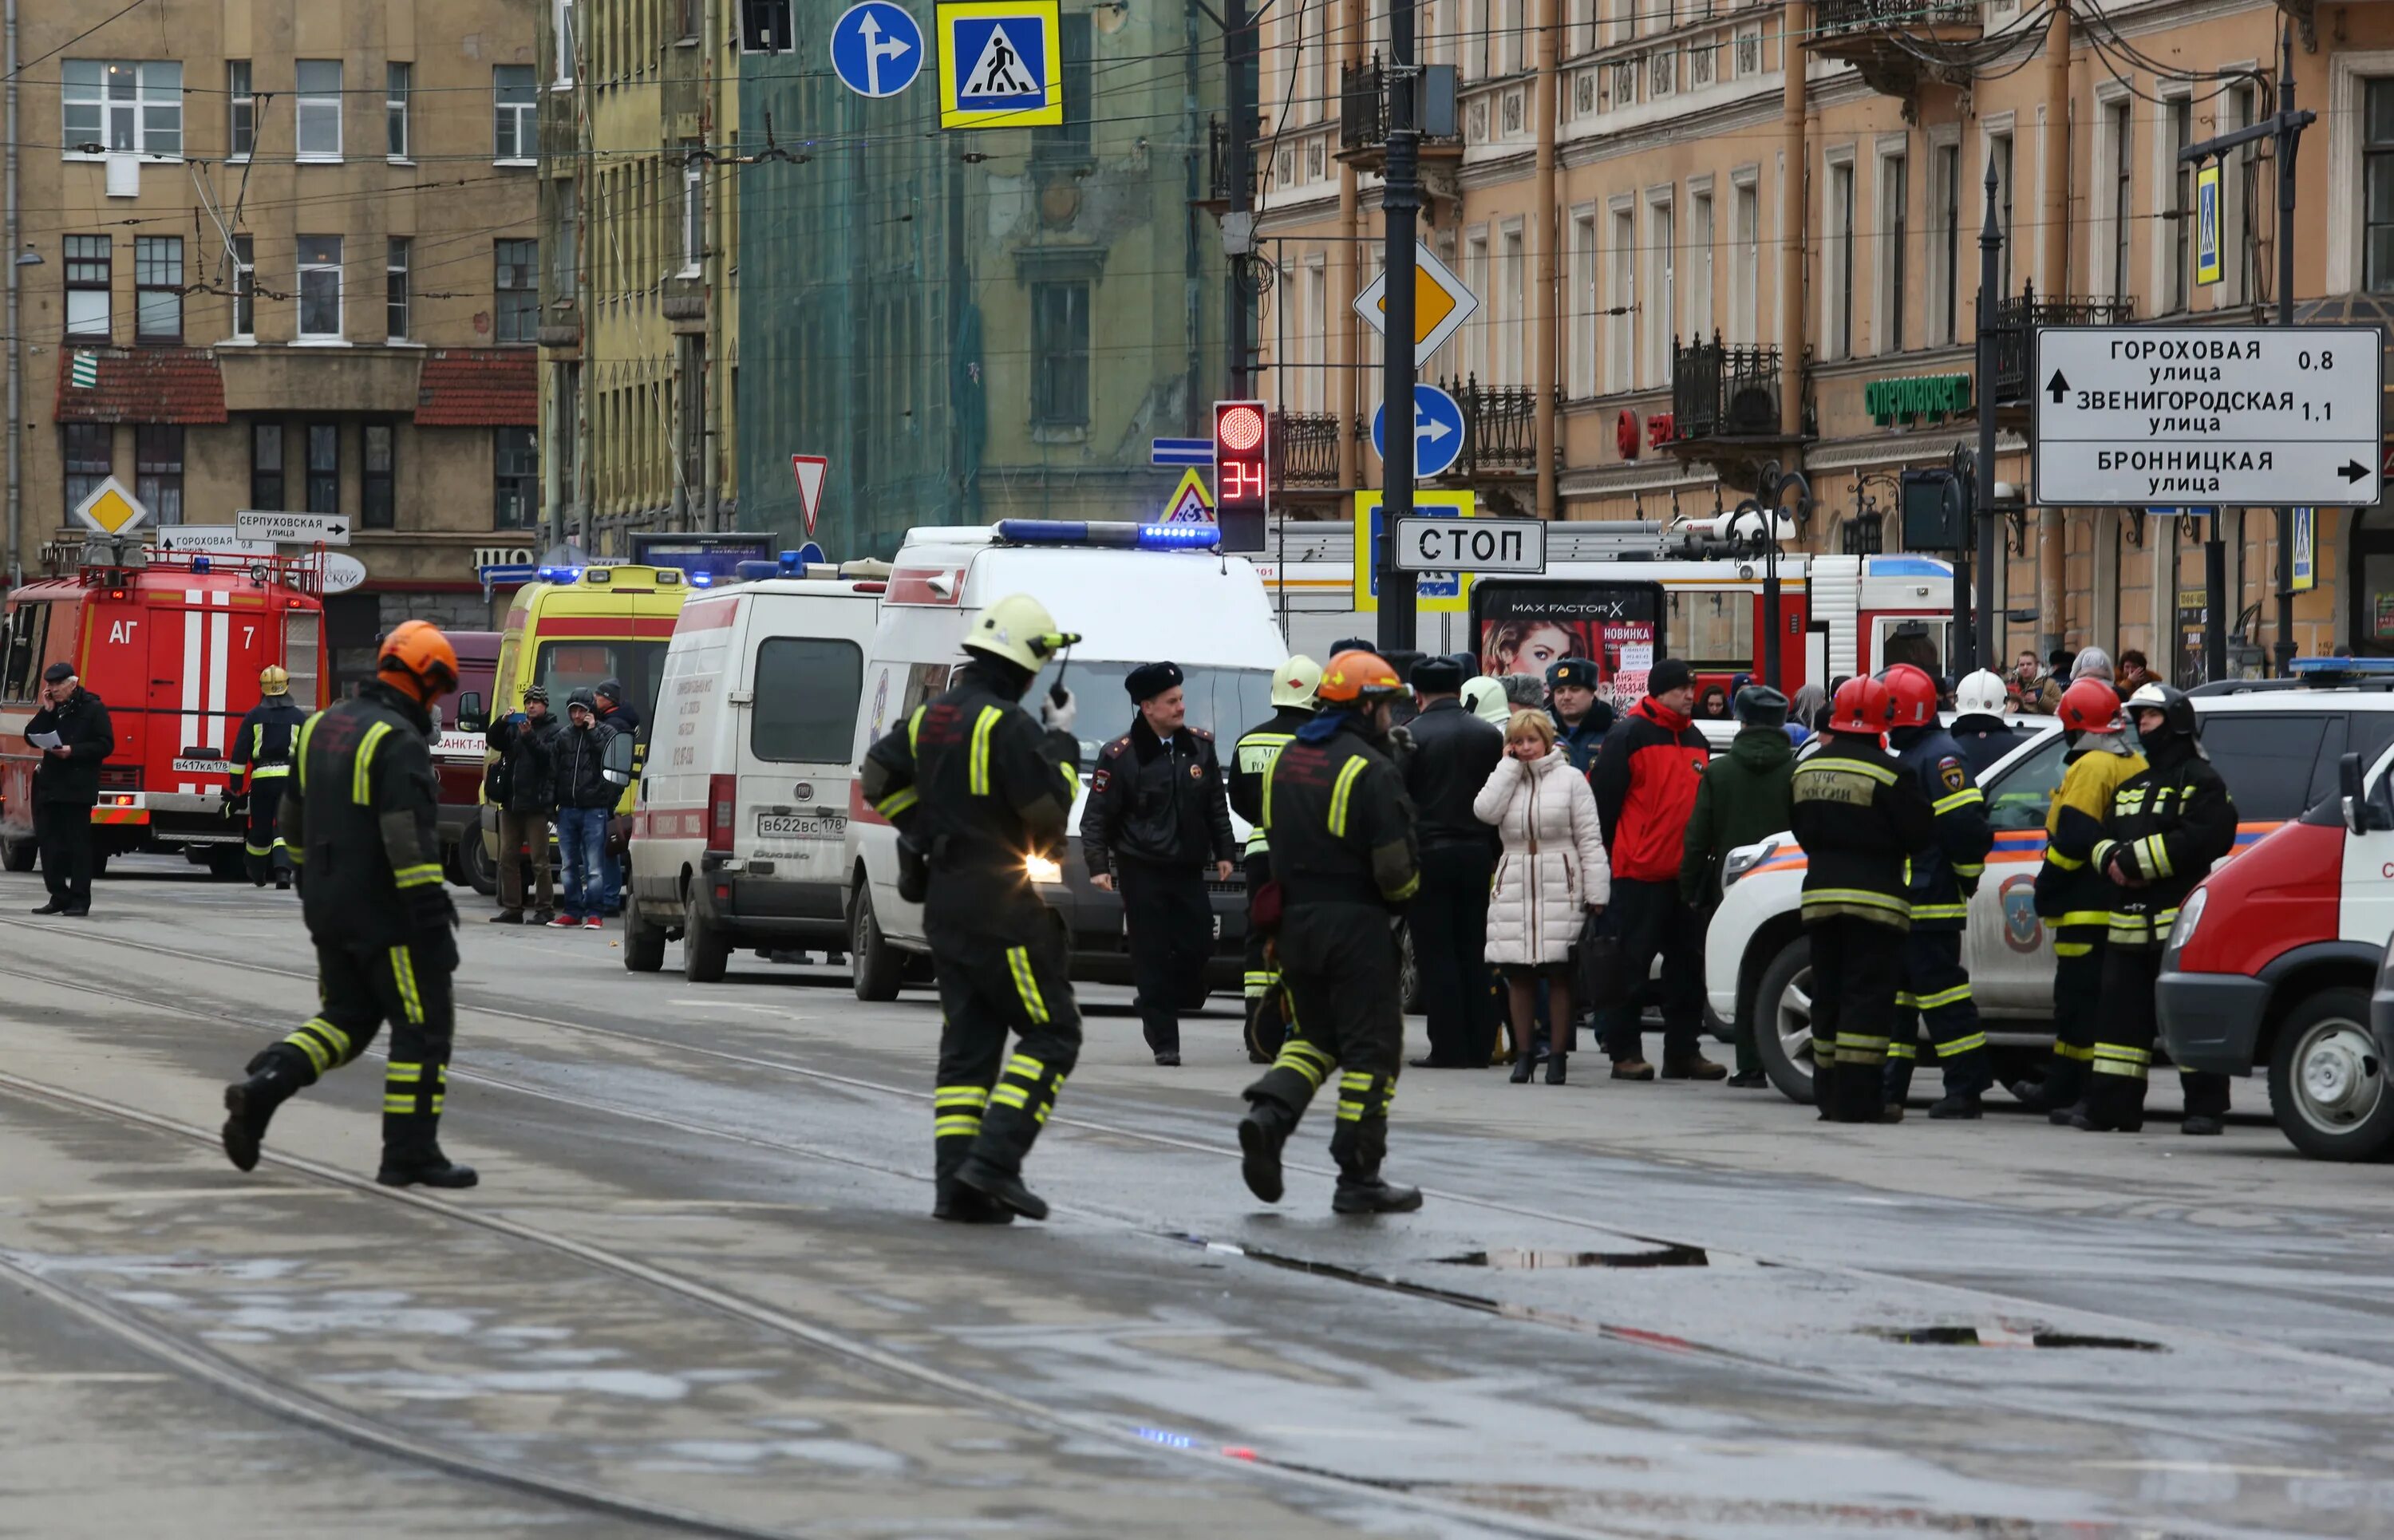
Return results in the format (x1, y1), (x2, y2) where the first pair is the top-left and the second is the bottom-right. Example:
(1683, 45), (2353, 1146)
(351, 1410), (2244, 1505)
(0, 860), (2394, 1540)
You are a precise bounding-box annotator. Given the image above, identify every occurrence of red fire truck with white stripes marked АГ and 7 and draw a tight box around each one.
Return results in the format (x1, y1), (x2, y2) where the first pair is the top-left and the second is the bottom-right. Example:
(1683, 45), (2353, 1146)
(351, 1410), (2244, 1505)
(0, 543), (326, 877)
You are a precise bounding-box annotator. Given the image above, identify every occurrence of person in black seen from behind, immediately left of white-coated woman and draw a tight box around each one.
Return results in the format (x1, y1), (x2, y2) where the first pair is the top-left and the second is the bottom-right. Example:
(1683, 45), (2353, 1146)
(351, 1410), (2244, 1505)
(1398, 658), (1506, 1071)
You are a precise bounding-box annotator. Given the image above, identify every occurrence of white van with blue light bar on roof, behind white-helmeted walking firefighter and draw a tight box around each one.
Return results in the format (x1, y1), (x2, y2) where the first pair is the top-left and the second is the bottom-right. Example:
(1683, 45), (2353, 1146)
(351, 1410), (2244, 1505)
(847, 519), (1288, 1006)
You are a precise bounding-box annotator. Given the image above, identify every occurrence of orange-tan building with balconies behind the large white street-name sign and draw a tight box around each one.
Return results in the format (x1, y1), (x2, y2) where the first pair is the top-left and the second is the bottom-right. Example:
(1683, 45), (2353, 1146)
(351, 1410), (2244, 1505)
(1259, 0), (2394, 668)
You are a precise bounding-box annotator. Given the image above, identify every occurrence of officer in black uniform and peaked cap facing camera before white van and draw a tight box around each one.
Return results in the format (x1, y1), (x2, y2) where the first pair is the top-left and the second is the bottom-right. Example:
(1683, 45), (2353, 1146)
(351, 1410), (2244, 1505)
(1080, 663), (1235, 1066)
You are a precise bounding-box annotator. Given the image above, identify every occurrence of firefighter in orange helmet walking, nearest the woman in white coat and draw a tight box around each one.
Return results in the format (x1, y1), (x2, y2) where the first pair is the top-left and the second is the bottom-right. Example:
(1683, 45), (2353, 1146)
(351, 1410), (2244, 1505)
(1238, 651), (1422, 1214)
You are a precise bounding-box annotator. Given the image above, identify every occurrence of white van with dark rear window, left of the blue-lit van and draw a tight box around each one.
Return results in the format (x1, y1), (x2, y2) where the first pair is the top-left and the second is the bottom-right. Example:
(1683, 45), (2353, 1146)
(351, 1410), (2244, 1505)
(622, 563), (886, 982)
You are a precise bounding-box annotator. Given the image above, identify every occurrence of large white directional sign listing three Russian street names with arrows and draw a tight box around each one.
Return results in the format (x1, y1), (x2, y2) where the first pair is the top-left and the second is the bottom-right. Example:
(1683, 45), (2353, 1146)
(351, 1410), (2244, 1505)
(2030, 326), (2384, 507)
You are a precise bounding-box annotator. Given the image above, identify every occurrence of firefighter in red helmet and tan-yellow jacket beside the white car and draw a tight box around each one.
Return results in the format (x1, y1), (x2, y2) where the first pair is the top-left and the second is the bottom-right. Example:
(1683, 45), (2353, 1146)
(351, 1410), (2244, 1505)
(2011, 680), (2145, 1123)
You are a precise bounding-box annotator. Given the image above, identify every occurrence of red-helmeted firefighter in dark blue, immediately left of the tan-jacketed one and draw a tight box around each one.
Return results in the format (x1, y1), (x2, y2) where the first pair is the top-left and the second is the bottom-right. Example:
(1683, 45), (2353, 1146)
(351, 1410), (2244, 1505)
(1882, 663), (1994, 1121)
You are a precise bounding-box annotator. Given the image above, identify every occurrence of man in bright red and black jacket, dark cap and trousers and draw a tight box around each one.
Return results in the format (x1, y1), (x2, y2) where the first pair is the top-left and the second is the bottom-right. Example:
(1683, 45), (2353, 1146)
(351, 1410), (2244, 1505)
(1587, 658), (1728, 1080)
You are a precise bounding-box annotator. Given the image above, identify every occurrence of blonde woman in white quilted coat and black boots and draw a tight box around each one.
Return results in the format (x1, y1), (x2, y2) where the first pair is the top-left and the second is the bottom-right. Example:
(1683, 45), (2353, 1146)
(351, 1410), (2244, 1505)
(1472, 711), (1614, 1085)
